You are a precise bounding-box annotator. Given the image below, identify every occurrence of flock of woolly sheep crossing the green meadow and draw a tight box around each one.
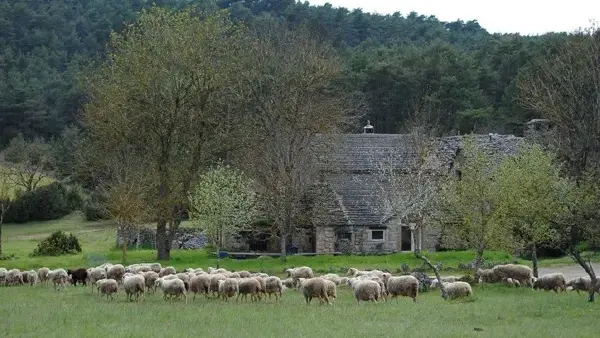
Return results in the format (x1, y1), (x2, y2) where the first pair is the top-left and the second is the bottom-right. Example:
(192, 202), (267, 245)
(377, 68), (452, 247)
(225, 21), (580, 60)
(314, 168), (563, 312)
(0, 263), (599, 304)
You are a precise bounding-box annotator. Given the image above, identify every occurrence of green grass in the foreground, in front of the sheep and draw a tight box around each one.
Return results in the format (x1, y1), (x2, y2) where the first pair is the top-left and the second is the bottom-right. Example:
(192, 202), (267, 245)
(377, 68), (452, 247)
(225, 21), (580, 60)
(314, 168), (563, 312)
(0, 285), (599, 337)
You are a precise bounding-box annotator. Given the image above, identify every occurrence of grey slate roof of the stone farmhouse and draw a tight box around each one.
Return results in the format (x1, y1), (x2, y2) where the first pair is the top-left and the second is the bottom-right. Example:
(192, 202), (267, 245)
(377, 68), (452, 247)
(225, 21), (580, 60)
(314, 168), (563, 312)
(319, 134), (522, 226)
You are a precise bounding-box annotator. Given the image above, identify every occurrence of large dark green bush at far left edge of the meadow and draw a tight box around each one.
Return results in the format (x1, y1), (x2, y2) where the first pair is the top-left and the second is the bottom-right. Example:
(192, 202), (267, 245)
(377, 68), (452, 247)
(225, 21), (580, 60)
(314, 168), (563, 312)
(5, 182), (82, 223)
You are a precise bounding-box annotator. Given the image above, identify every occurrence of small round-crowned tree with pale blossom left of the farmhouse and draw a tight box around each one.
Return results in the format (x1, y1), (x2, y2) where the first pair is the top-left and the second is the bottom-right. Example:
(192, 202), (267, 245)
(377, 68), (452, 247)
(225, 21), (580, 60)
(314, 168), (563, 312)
(189, 164), (256, 268)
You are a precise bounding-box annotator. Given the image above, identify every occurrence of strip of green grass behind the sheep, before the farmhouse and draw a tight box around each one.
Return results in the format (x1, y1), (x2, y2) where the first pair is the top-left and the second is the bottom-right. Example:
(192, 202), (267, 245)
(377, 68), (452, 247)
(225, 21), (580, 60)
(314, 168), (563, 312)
(0, 213), (596, 274)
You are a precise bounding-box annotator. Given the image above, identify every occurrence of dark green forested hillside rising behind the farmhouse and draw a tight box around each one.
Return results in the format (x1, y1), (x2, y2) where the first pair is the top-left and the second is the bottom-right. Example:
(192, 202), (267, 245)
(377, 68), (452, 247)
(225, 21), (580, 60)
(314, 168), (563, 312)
(0, 0), (567, 145)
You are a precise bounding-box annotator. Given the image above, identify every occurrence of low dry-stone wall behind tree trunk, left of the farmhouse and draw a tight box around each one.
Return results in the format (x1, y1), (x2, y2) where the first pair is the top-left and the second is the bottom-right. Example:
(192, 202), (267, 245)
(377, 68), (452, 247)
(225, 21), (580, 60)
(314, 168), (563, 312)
(117, 227), (207, 249)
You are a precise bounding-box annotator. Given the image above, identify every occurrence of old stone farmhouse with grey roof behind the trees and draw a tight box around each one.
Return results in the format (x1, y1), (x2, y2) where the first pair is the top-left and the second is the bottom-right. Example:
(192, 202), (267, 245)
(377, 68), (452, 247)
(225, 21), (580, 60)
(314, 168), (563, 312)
(276, 120), (550, 253)
